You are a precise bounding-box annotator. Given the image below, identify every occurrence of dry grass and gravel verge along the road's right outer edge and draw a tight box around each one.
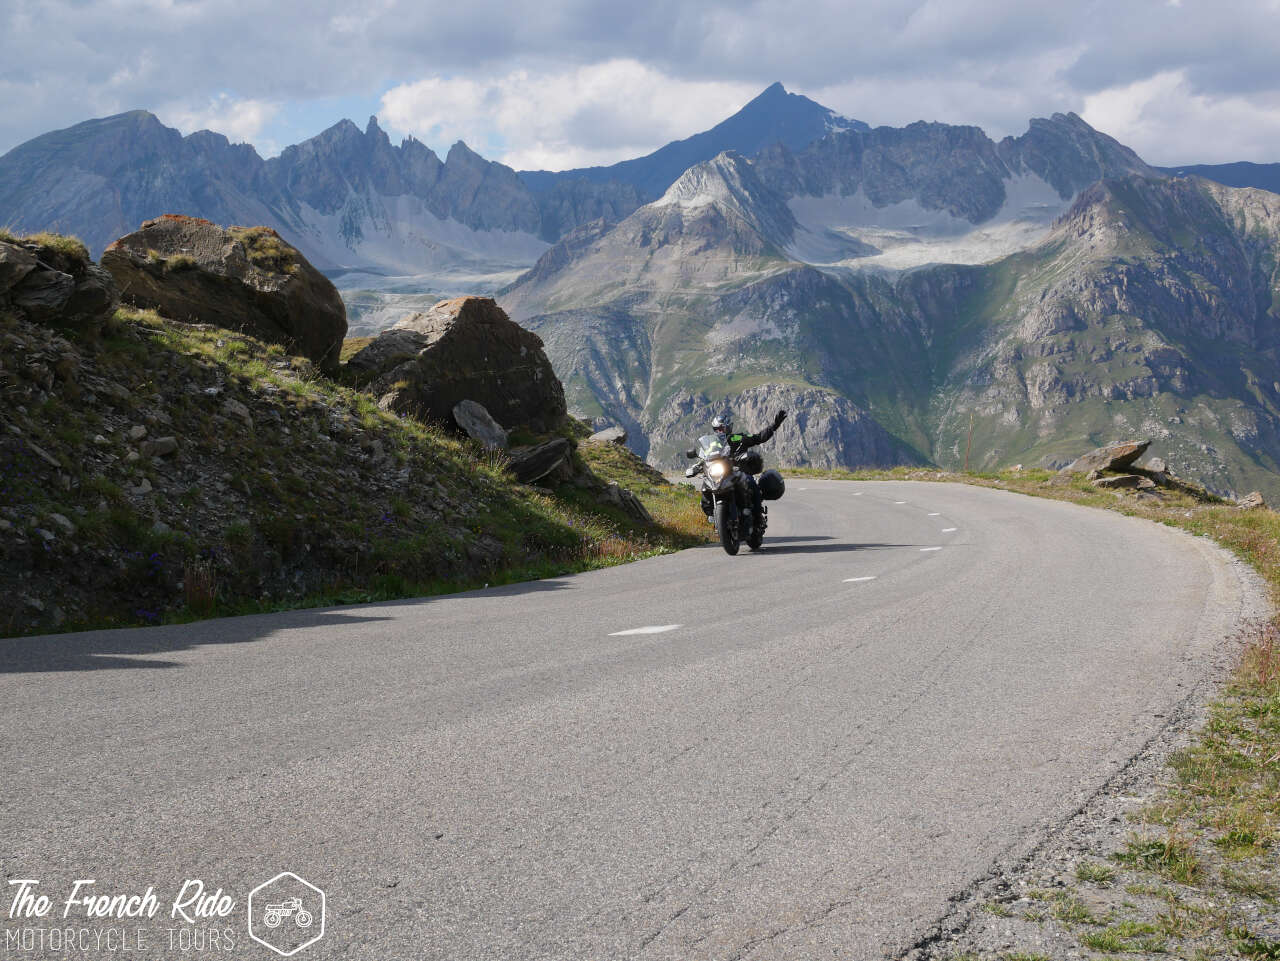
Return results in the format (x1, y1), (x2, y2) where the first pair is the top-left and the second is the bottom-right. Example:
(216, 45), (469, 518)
(787, 468), (1280, 961)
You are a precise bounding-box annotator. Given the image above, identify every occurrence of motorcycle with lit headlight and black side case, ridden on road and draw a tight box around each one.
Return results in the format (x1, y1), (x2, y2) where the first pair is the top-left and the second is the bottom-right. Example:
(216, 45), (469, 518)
(685, 434), (785, 554)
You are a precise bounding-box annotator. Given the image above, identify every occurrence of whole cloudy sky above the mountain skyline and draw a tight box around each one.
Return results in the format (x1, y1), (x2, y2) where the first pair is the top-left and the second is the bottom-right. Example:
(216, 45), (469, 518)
(0, 0), (1280, 169)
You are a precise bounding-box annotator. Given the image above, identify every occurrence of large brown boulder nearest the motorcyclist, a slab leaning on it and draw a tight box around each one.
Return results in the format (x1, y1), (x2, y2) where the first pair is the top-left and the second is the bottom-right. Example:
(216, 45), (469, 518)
(347, 297), (564, 433)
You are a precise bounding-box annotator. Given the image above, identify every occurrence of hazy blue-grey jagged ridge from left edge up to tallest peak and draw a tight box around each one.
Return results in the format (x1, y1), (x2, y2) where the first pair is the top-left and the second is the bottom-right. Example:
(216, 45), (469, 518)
(0, 84), (856, 289)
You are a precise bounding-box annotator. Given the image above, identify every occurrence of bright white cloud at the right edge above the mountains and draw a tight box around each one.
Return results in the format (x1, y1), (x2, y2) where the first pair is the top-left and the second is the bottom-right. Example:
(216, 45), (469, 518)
(1080, 70), (1280, 166)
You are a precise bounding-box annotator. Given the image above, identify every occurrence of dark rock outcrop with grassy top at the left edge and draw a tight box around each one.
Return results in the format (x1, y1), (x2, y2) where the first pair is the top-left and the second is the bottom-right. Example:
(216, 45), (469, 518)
(0, 237), (119, 334)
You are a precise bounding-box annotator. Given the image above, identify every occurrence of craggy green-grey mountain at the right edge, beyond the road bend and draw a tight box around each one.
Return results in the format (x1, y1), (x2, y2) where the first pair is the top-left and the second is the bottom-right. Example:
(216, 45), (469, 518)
(925, 177), (1280, 494)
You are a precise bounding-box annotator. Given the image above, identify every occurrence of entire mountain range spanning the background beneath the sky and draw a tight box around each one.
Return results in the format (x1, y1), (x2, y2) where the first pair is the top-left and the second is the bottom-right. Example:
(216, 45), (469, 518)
(0, 84), (1280, 495)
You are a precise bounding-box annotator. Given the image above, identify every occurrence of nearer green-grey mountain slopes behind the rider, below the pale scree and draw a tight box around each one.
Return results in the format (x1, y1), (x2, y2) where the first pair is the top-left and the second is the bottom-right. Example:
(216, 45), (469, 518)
(503, 171), (1280, 504)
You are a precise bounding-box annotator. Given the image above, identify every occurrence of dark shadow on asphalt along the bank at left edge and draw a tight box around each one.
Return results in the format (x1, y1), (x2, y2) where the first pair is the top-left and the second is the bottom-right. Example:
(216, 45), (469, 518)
(0, 608), (389, 674)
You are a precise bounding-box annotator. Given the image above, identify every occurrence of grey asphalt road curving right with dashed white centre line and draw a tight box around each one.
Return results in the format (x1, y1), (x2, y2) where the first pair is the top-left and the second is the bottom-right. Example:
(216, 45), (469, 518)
(0, 480), (1261, 961)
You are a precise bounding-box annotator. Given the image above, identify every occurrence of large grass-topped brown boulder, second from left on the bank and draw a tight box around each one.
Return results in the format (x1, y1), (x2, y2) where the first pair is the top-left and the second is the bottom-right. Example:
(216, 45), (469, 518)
(102, 214), (347, 371)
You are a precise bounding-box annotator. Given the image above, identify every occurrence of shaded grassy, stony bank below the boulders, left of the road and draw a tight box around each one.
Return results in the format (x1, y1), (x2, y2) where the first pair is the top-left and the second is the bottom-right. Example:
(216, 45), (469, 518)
(0, 310), (707, 636)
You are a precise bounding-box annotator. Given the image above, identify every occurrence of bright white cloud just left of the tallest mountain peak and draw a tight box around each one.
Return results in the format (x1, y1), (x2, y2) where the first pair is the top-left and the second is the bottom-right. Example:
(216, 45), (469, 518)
(379, 59), (760, 170)
